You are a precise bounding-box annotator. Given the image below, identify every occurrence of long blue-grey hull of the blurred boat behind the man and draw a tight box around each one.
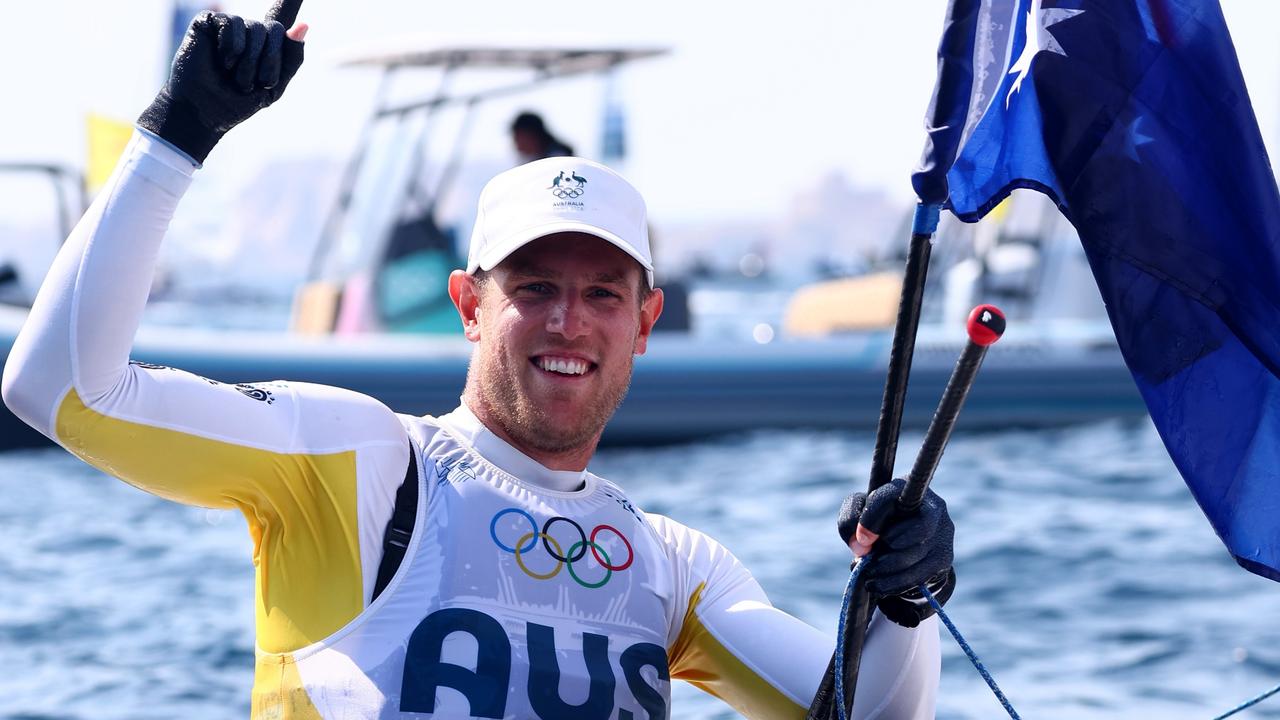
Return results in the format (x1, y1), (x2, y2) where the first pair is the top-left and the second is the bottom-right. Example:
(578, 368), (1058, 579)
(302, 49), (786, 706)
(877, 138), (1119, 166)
(0, 297), (1143, 448)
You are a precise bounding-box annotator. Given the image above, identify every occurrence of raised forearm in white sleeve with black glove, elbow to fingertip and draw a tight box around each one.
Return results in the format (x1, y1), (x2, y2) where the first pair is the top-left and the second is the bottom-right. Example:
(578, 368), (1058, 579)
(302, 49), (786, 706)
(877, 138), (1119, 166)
(3, 0), (306, 430)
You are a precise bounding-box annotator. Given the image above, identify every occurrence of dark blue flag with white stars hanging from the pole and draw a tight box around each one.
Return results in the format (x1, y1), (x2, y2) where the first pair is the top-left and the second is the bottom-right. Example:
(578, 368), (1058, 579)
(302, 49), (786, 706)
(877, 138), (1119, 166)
(947, 0), (1280, 580)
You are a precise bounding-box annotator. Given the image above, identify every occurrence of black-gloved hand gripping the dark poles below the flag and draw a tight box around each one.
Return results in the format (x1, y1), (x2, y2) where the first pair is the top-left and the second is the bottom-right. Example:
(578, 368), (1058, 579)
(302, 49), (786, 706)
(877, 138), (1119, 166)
(838, 478), (956, 628)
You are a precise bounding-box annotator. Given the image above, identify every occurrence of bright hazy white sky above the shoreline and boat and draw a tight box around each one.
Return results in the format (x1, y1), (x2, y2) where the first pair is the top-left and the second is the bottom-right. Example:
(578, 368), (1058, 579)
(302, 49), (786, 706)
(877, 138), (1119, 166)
(0, 0), (1280, 219)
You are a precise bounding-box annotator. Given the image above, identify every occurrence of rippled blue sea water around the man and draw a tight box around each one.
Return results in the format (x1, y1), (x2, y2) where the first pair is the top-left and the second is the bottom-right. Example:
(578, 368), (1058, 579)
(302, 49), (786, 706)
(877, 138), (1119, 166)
(0, 423), (1280, 720)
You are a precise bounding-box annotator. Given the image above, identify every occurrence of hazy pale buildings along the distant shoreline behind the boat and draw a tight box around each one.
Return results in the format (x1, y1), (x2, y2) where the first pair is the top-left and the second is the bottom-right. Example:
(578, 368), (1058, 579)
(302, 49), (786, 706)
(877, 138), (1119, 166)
(142, 155), (909, 299)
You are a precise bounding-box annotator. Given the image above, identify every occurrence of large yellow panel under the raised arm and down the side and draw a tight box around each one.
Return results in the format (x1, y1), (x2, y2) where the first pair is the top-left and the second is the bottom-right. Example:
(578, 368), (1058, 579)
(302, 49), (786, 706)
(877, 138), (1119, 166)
(56, 389), (364, 652)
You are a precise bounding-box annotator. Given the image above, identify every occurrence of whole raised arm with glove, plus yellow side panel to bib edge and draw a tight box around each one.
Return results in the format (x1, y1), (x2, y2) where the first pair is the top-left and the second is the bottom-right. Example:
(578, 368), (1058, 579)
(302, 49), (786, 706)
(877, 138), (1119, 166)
(3, 1), (408, 651)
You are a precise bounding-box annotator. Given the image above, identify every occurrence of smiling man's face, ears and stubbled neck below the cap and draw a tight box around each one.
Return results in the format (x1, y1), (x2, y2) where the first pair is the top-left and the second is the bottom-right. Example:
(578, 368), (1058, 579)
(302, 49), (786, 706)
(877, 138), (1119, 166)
(451, 233), (662, 454)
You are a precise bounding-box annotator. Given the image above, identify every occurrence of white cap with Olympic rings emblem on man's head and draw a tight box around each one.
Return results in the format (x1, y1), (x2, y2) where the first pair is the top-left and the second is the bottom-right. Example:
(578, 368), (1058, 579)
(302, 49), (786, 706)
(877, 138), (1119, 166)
(467, 158), (653, 287)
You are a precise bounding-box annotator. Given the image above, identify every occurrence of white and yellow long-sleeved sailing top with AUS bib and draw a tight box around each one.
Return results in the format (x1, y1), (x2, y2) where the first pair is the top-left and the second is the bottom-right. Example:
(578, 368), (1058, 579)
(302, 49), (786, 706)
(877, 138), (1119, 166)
(4, 133), (940, 720)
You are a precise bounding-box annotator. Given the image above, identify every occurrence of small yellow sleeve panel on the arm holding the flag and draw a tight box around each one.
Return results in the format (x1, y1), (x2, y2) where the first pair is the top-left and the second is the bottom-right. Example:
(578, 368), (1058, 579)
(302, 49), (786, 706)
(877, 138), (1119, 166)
(667, 583), (809, 720)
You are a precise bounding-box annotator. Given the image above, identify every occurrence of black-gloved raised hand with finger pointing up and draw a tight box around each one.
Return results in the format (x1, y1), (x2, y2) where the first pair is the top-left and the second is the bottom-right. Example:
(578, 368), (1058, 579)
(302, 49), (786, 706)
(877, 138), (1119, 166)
(138, 0), (306, 163)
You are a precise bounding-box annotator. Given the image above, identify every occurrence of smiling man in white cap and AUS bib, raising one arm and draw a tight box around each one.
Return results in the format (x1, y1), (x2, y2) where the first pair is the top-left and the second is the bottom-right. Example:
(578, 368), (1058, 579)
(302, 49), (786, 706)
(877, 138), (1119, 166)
(3, 0), (951, 720)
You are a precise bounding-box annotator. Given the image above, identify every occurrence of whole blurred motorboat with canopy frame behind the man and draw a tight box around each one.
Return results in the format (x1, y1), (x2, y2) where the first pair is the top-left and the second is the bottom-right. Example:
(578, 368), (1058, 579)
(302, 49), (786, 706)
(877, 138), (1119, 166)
(0, 42), (1144, 448)
